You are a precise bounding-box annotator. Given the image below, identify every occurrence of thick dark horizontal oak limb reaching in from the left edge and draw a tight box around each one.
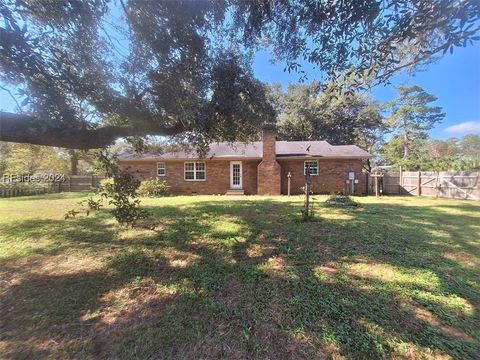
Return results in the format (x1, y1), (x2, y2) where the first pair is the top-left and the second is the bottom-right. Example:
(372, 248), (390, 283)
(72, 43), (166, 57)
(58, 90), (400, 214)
(0, 112), (185, 150)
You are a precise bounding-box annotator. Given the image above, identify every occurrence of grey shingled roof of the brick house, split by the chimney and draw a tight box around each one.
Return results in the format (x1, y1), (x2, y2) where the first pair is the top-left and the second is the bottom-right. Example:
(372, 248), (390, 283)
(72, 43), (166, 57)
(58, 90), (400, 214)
(119, 141), (371, 161)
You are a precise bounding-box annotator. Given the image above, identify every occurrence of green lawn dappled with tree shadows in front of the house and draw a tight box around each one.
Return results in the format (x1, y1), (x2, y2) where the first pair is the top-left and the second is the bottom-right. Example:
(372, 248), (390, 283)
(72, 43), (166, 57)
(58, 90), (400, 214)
(0, 194), (480, 359)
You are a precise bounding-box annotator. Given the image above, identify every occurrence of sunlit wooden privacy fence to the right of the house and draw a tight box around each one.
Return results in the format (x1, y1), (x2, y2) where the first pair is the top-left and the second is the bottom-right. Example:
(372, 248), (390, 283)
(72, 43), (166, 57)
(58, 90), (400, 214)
(367, 171), (480, 200)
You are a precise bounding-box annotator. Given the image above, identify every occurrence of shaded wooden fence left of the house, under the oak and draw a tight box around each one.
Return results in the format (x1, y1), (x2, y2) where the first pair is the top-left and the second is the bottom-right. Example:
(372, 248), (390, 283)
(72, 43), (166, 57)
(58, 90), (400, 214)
(0, 175), (105, 197)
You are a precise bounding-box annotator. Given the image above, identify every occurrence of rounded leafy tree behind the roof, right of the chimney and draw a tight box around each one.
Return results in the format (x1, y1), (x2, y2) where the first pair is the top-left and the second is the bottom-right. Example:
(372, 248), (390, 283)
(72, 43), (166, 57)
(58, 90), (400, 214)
(272, 83), (384, 143)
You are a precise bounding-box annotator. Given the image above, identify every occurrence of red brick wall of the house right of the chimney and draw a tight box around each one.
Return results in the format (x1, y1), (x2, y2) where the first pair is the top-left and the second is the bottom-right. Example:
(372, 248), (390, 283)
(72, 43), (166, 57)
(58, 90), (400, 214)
(279, 159), (365, 195)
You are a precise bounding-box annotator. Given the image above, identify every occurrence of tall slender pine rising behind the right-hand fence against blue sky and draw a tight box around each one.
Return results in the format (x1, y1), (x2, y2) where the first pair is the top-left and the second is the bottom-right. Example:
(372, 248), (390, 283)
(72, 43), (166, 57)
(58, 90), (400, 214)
(385, 85), (445, 159)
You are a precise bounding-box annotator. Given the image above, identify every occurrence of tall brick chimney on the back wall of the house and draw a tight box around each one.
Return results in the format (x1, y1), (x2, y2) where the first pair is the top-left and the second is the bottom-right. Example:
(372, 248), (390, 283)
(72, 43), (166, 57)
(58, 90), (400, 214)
(257, 124), (281, 195)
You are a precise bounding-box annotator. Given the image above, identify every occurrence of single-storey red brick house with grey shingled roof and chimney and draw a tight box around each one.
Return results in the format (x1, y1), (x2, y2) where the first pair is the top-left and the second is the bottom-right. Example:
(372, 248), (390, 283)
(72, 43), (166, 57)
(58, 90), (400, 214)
(118, 126), (371, 195)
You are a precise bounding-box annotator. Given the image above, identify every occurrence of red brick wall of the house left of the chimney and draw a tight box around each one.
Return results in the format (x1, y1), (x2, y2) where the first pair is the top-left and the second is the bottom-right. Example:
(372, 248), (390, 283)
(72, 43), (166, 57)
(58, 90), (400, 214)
(119, 160), (260, 195)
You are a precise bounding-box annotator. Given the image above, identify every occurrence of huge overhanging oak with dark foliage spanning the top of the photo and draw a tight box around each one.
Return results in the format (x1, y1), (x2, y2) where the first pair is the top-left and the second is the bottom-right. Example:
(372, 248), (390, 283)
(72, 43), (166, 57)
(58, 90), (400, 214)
(0, 0), (480, 149)
